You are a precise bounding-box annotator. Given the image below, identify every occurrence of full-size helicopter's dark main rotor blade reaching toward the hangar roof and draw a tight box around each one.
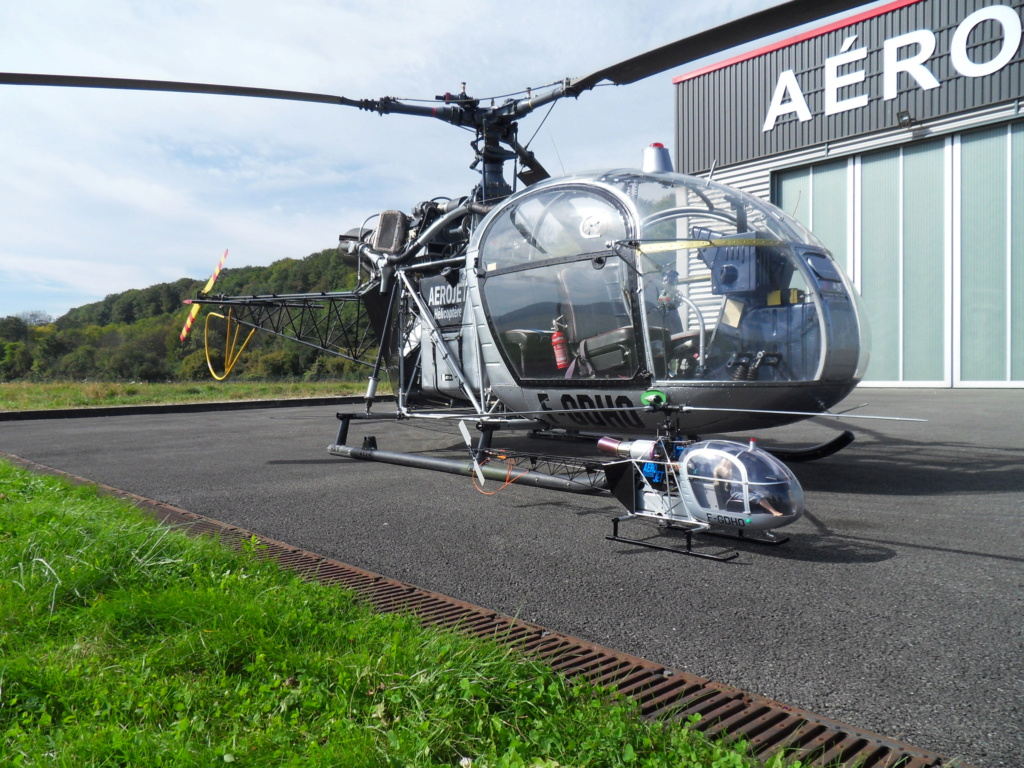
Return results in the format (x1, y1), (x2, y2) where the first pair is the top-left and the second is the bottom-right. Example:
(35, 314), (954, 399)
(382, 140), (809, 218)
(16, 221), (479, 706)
(569, 0), (869, 92)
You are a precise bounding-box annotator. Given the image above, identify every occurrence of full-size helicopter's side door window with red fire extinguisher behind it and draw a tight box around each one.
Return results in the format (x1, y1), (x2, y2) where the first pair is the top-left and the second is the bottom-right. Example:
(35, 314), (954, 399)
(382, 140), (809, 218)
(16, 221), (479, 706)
(480, 187), (640, 380)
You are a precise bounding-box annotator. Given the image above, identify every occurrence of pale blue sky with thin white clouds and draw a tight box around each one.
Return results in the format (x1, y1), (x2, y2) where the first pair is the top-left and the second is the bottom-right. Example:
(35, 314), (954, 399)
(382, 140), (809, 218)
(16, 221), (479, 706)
(0, 0), (880, 317)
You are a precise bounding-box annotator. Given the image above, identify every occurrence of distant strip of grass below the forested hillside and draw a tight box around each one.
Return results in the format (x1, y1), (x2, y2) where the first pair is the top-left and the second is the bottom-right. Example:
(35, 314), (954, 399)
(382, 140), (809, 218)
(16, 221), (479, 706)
(0, 379), (368, 412)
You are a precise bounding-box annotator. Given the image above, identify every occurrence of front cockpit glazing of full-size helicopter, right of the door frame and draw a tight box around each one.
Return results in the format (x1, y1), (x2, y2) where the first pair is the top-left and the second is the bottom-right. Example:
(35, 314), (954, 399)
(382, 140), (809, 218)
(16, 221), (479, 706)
(622, 183), (823, 382)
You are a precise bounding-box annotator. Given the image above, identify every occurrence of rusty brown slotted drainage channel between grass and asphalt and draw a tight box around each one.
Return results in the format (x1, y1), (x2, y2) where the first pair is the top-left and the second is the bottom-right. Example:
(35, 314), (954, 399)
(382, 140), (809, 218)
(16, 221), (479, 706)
(6, 453), (971, 768)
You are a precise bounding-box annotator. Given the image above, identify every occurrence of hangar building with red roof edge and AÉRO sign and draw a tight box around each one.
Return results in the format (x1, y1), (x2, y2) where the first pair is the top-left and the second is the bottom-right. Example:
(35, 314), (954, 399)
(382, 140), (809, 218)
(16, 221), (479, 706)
(674, 0), (1024, 387)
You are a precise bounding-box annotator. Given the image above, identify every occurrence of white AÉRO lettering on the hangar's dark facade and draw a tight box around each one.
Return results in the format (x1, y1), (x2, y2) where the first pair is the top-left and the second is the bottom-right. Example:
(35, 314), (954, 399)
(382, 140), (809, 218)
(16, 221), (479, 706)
(761, 5), (1022, 132)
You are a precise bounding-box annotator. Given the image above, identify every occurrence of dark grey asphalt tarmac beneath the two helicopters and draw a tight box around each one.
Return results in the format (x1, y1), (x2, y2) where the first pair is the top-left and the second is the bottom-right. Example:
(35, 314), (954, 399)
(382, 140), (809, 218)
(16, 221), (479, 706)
(0, 389), (1024, 768)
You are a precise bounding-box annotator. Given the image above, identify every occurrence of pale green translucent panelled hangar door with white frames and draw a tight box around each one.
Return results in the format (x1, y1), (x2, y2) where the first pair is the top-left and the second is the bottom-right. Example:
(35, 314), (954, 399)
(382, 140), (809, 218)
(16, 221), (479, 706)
(772, 123), (1024, 387)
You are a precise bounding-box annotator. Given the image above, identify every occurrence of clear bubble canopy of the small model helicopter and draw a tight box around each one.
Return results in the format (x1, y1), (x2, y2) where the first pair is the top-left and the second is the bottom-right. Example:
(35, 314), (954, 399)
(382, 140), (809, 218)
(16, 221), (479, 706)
(680, 440), (804, 521)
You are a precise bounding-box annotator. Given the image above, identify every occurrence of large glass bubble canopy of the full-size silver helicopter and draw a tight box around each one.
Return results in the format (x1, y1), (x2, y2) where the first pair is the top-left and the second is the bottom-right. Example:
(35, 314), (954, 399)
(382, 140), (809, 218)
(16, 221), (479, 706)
(469, 169), (868, 410)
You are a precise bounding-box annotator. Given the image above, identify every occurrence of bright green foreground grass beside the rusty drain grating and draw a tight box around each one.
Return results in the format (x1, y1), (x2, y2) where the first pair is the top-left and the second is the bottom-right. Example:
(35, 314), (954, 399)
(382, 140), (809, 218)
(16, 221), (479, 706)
(0, 462), (790, 768)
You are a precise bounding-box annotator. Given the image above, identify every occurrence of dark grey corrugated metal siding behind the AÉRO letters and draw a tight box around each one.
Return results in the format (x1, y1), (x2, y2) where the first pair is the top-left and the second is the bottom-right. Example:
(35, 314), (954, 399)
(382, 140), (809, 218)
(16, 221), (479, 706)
(676, 0), (1024, 173)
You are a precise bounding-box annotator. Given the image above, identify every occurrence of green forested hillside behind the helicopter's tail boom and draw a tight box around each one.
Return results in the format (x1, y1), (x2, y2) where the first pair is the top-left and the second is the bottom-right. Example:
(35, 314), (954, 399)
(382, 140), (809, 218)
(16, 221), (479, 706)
(0, 248), (355, 381)
